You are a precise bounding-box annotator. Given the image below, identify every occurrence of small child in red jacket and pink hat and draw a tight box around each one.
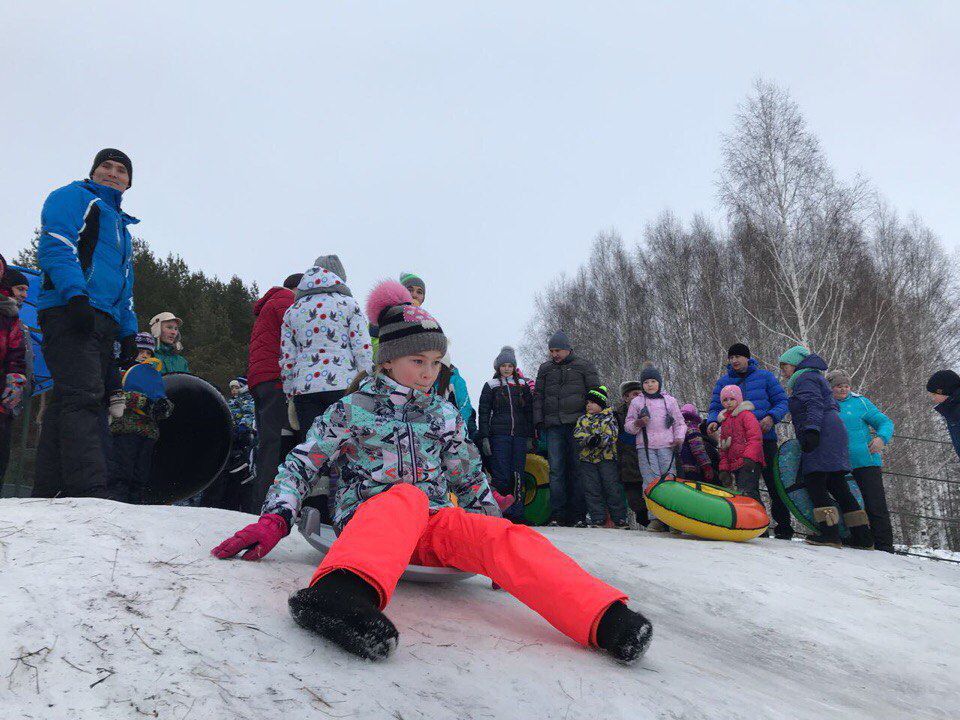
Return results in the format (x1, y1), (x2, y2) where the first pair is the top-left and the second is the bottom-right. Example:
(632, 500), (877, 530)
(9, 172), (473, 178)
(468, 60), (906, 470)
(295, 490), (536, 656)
(717, 385), (764, 502)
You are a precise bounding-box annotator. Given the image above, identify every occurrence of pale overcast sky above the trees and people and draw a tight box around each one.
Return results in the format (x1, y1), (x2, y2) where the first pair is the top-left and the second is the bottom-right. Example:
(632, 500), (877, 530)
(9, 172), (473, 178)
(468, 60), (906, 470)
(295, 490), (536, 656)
(0, 0), (960, 399)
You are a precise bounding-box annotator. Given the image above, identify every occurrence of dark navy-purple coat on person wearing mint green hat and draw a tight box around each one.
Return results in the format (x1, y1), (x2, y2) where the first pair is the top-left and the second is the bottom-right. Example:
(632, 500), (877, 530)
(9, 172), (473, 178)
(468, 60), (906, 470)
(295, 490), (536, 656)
(789, 353), (850, 475)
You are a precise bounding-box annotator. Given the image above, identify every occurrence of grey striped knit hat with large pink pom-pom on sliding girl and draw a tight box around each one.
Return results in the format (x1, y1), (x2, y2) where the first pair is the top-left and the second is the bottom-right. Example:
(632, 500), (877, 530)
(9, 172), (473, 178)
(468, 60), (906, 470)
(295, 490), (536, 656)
(367, 280), (447, 363)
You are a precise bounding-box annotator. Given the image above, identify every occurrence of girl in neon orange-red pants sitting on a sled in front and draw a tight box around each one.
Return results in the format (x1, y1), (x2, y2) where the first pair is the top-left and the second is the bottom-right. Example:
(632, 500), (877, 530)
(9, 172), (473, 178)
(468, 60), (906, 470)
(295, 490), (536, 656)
(213, 281), (652, 663)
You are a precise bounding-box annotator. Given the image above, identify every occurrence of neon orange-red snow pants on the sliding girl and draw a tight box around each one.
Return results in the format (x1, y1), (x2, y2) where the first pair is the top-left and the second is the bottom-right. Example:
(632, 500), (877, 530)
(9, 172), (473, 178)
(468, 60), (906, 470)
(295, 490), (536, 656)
(310, 484), (627, 645)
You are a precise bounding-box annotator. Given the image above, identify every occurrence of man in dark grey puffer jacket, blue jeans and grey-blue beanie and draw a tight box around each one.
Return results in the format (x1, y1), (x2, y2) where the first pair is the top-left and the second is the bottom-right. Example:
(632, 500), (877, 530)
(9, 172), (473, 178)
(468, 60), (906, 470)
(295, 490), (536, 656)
(533, 330), (600, 527)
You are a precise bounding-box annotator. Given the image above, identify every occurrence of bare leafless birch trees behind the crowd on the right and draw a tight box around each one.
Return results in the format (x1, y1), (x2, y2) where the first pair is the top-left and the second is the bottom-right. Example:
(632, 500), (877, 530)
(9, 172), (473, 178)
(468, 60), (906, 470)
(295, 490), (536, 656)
(521, 81), (960, 550)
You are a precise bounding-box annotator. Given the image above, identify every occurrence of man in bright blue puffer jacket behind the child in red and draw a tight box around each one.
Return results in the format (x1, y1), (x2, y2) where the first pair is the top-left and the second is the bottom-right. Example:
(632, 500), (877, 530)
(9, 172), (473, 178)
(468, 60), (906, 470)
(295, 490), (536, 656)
(707, 343), (793, 540)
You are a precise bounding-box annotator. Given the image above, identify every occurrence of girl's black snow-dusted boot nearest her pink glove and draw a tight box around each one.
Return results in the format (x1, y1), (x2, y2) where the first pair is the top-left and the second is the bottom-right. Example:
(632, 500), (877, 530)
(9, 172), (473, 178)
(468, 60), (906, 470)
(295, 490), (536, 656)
(289, 570), (400, 660)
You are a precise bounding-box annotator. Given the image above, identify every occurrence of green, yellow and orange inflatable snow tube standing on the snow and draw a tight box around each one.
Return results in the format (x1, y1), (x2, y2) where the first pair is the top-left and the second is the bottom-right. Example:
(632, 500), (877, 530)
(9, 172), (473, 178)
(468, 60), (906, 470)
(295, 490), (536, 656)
(643, 475), (770, 542)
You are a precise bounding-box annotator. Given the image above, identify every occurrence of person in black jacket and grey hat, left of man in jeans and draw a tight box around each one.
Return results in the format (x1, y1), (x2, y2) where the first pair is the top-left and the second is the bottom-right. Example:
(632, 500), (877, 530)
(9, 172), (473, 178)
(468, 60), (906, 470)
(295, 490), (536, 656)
(477, 346), (533, 520)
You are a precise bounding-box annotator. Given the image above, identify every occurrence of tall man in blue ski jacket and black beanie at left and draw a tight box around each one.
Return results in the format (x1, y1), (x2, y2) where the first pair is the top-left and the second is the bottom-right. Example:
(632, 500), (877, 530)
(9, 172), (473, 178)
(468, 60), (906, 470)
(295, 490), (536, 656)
(33, 149), (139, 497)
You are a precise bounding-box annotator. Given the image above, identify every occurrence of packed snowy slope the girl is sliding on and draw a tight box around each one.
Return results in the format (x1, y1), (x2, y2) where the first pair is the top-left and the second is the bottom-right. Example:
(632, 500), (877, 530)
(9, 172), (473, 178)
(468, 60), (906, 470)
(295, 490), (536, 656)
(0, 499), (960, 720)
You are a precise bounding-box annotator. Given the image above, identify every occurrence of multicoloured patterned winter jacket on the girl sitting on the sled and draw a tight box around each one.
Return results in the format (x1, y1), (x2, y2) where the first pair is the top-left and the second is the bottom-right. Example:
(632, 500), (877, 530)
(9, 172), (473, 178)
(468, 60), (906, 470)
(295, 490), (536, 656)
(263, 374), (500, 530)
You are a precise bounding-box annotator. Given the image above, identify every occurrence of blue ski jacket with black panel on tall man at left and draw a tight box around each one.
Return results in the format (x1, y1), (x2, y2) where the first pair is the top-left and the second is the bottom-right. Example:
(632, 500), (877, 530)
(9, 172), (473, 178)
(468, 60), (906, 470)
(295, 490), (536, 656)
(37, 180), (140, 338)
